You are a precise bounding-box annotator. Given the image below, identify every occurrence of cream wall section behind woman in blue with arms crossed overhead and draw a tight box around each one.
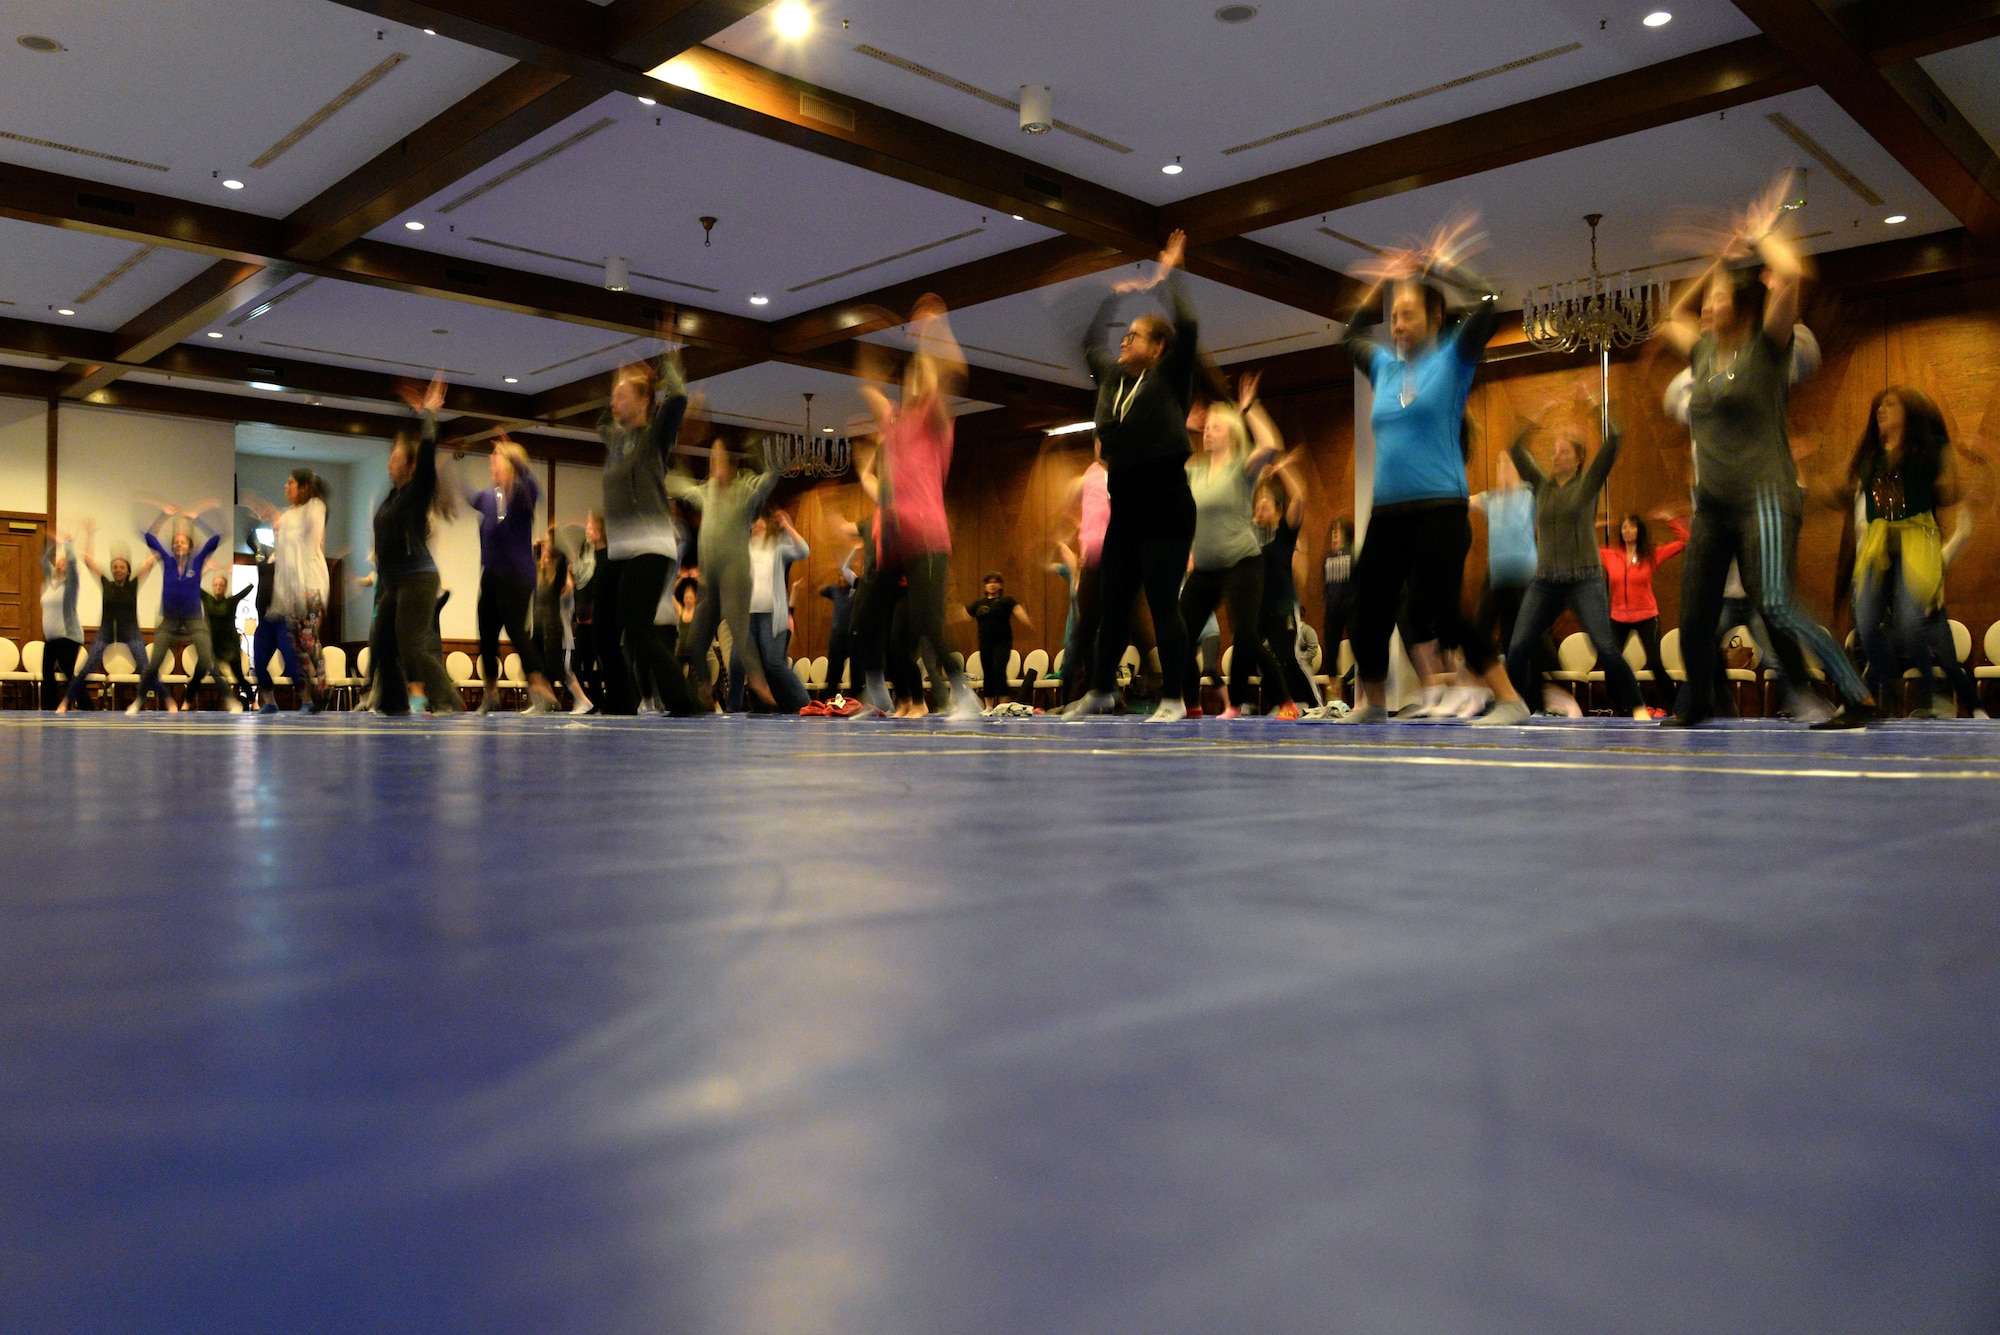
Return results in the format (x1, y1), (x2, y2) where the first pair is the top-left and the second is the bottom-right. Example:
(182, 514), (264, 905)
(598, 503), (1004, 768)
(57, 404), (236, 626)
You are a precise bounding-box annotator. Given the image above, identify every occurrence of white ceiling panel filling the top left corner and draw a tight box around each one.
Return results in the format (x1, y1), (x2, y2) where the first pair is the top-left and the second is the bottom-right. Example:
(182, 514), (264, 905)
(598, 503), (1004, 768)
(0, 0), (512, 218)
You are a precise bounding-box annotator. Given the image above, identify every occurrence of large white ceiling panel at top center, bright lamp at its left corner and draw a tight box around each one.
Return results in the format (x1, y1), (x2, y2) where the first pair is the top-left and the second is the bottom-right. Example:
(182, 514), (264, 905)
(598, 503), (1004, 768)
(712, 0), (1756, 204)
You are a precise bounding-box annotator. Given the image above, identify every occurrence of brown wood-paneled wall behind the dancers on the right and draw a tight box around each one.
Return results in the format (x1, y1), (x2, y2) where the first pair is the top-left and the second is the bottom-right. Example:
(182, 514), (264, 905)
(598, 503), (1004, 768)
(764, 280), (2000, 658)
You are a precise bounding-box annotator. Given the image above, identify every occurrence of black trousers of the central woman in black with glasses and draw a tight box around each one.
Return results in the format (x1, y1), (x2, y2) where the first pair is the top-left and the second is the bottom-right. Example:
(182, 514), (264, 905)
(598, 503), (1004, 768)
(1090, 503), (1206, 699)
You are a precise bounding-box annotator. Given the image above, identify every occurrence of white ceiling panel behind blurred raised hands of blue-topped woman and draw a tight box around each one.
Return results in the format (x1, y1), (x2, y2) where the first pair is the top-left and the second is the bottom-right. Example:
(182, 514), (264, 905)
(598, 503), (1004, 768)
(1252, 88), (1958, 304)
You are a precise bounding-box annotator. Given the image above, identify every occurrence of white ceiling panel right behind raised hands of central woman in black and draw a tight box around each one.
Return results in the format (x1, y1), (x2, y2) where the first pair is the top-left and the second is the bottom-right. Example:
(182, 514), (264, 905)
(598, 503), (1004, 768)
(866, 262), (1340, 386)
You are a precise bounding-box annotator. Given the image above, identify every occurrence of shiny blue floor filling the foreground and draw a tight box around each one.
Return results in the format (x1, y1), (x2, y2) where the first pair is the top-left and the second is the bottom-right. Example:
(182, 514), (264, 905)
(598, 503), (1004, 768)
(0, 713), (2000, 1335)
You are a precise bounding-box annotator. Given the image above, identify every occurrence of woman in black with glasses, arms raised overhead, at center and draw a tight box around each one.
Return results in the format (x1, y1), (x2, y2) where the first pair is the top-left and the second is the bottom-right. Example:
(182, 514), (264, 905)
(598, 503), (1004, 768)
(1070, 232), (1198, 723)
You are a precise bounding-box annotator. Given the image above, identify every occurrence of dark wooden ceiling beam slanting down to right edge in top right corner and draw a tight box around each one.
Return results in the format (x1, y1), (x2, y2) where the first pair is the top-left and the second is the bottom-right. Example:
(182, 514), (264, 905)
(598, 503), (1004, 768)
(1734, 0), (2000, 246)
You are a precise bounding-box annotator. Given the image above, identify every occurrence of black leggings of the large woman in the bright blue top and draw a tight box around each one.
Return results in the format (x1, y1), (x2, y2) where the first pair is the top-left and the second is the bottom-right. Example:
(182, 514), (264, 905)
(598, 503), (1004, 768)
(1350, 500), (1472, 681)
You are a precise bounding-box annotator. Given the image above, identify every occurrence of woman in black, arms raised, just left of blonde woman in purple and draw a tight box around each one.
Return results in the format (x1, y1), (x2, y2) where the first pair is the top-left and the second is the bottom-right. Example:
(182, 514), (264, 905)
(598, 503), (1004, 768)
(368, 369), (462, 715)
